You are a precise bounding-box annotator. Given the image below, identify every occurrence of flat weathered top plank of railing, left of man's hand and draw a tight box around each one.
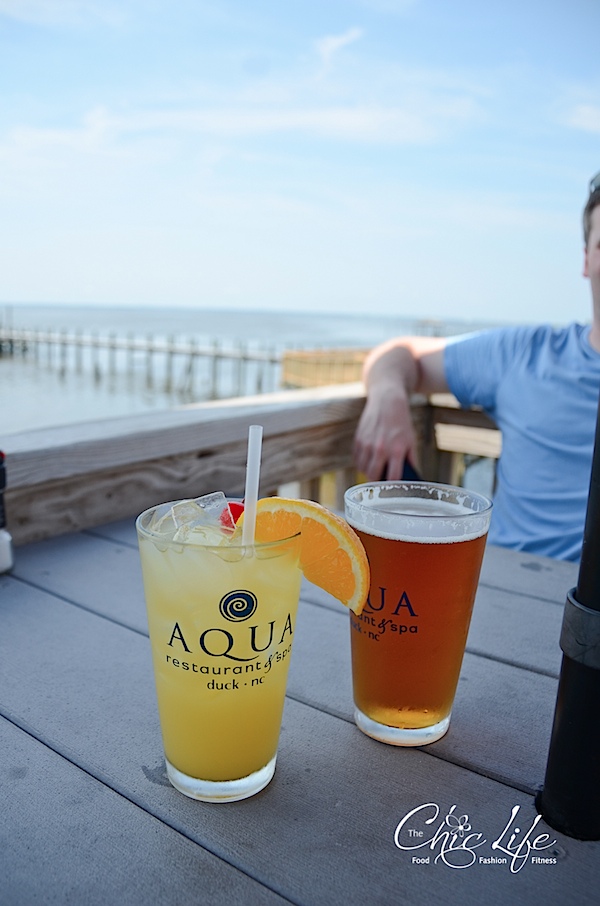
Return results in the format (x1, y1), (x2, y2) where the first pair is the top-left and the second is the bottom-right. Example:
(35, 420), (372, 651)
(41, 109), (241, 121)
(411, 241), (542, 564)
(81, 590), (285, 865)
(3, 385), (364, 493)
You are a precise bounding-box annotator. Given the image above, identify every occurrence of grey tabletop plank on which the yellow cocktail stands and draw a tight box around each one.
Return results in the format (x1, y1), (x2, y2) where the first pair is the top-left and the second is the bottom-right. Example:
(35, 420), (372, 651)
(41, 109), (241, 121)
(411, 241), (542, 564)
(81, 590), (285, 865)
(0, 580), (600, 906)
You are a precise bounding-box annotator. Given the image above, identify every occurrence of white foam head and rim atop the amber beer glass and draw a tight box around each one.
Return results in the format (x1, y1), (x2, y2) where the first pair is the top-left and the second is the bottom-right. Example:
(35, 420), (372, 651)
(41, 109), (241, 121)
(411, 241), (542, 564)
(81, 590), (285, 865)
(345, 481), (492, 544)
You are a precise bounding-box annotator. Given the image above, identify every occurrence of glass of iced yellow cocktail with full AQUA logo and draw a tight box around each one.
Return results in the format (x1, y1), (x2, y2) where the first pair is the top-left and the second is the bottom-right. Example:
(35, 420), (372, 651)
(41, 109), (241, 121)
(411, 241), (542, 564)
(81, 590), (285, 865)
(136, 501), (302, 802)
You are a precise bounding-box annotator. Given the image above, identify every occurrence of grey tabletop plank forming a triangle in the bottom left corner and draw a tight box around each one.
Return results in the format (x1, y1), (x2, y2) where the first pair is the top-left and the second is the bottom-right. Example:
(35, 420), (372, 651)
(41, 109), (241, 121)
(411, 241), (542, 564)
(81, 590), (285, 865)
(0, 718), (288, 906)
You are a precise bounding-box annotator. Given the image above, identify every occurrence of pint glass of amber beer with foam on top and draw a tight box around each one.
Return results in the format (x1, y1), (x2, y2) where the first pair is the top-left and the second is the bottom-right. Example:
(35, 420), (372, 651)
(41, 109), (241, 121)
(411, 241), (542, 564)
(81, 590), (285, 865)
(345, 481), (492, 746)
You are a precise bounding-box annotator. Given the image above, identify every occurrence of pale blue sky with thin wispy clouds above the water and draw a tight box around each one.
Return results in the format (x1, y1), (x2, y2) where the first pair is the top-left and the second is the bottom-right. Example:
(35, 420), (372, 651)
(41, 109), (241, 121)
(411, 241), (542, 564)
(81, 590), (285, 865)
(0, 0), (600, 323)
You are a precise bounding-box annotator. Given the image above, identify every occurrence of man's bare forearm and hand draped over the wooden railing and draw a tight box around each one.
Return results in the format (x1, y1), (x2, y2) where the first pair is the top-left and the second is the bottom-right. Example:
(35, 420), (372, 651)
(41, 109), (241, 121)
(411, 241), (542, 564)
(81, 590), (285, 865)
(354, 337), (448, 481)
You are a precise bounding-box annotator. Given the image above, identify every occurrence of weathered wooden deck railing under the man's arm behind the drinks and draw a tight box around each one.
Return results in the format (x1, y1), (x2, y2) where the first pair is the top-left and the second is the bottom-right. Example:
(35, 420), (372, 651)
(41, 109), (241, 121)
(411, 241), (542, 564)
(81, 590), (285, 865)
(2, 384), (499, 544)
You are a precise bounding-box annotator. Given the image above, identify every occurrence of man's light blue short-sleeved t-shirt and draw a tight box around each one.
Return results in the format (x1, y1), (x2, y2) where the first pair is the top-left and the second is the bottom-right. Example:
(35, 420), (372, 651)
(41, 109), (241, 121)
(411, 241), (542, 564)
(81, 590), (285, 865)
(444, 324), (600, 560)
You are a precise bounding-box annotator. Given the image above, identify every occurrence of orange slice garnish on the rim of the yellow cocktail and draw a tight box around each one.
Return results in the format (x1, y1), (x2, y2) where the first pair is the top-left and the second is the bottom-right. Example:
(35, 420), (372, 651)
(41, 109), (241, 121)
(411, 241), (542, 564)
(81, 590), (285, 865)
(235, 497), (369, 614)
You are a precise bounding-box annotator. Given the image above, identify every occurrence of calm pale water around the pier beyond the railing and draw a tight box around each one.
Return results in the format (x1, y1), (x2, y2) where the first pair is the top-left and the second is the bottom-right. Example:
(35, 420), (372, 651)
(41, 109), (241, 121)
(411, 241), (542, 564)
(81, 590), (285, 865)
(0, 305), (502, 436)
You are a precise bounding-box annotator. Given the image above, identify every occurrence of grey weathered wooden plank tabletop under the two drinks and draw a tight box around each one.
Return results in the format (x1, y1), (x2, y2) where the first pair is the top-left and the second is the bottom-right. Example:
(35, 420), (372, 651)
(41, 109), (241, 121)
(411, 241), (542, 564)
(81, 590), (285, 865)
(0, 520), (600, 906)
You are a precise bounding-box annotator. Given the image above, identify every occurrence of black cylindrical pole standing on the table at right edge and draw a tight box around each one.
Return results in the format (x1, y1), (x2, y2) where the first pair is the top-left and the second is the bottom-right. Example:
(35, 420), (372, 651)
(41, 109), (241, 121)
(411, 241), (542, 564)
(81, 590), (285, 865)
(536, 392), (600, 840)
